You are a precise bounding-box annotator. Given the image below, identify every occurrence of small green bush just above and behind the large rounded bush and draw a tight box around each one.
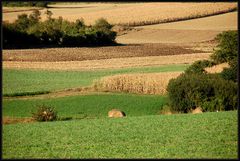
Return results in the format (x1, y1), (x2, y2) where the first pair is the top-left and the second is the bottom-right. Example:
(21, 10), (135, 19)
(185, 60), (216, 74)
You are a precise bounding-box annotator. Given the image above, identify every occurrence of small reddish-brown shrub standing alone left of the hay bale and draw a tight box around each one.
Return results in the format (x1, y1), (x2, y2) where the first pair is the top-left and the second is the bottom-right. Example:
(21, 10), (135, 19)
(32, 105), (57, 121)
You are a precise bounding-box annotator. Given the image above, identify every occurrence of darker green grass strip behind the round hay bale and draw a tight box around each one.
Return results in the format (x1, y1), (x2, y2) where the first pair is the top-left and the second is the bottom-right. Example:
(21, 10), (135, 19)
(2, 94), (167, 118)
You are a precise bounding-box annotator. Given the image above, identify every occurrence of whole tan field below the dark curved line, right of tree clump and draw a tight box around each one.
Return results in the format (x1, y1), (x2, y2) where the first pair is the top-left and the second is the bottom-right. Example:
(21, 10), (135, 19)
(116, 12), (238, 45)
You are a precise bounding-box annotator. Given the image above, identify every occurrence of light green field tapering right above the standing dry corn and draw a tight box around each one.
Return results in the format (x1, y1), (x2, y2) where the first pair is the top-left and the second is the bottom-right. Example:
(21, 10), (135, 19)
(3, 64), (189, 95)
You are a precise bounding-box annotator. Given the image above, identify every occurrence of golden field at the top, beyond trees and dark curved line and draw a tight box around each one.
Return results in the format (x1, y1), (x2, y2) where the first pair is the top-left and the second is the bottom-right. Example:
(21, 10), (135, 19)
(3, 2), (237, 26)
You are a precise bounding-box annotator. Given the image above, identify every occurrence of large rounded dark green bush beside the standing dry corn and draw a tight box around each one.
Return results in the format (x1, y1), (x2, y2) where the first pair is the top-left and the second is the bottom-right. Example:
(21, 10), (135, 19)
(167, 74), (237, 113)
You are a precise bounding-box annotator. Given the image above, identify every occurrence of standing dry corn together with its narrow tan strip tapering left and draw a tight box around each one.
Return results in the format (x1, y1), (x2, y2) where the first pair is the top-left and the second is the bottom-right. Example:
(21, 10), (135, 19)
(3, 72), (182, 100)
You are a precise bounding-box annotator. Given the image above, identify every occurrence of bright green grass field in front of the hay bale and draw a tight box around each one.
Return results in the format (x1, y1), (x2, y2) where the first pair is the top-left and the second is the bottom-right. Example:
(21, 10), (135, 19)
(2, 111), (238, 159)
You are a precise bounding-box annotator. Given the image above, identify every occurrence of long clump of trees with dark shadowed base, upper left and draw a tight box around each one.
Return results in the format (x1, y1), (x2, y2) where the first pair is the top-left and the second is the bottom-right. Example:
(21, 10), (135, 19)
(3, 10), (116, 48)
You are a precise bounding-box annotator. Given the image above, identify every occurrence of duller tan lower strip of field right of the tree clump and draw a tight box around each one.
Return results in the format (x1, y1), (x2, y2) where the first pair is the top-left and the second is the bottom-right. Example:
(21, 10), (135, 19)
(116, 29), (221, 44)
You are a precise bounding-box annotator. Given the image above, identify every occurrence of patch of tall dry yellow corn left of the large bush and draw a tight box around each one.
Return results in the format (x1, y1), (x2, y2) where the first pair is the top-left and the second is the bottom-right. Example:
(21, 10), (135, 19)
(94, 72), (182, 95)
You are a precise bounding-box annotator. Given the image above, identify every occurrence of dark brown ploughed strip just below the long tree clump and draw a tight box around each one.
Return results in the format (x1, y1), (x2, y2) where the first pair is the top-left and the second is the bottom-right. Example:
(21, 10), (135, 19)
(3, 43), (204, 62)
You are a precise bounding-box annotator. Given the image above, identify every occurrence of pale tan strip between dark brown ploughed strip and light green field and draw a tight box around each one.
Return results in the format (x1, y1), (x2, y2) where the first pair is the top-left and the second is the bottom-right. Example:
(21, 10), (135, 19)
(3, 53), (212, 70)
